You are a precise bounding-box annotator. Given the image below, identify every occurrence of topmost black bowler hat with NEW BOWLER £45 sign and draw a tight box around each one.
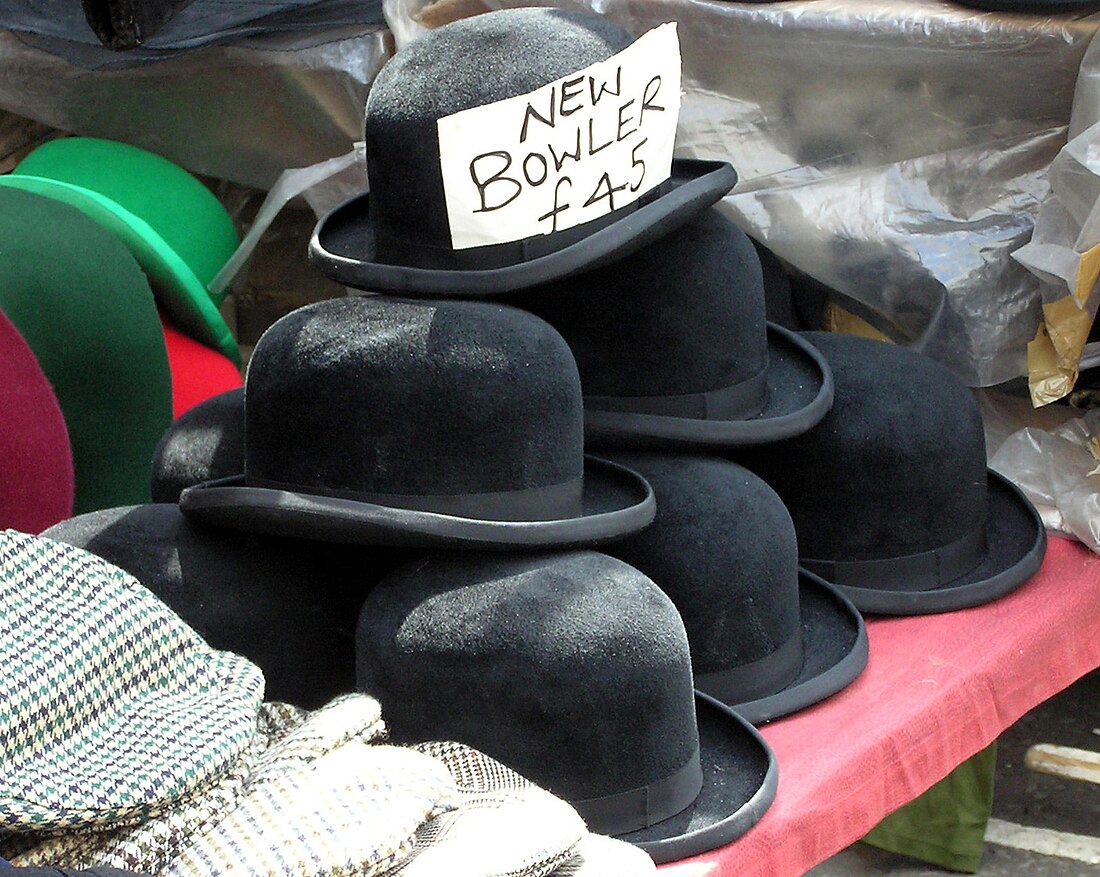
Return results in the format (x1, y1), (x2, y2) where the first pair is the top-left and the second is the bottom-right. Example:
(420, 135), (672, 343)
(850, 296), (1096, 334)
(310, 9), (736, 297)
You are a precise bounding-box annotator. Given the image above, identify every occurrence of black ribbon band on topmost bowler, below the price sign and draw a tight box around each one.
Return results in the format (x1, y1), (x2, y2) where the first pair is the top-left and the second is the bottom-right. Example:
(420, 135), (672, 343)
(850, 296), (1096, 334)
(374, 179), (672, 271)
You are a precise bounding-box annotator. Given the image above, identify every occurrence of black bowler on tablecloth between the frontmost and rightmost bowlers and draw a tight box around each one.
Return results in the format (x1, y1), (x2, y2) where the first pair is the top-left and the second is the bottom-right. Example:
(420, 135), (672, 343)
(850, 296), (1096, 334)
(607, 452), (867, 723)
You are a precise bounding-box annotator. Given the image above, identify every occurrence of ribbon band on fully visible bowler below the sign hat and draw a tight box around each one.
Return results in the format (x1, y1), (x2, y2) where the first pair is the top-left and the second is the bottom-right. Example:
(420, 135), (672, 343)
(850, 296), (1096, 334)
(245, 475), (584, 520)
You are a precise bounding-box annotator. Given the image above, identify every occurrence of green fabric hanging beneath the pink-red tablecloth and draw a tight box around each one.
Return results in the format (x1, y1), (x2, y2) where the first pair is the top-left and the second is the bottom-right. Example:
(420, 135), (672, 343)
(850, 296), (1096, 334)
(864, 742), (997, 874)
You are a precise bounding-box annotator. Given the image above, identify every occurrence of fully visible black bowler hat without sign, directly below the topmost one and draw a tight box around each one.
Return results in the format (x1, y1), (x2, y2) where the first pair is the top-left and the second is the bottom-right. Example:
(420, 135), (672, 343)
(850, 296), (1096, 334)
(179, 296), (655, 549)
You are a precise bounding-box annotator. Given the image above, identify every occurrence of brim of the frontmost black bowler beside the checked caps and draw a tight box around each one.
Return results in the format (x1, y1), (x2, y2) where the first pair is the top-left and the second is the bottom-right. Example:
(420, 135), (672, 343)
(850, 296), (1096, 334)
(616, 691), (779, 865)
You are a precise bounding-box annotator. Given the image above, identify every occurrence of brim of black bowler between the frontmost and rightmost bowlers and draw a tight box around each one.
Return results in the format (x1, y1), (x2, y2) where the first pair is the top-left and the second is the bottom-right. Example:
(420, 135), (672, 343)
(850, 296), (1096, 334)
(717, 570), (868, 725)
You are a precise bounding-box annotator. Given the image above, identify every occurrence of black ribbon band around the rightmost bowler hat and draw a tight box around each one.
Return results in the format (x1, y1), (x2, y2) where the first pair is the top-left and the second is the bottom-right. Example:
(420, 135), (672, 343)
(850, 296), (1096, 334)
(799, 527), (986, 591)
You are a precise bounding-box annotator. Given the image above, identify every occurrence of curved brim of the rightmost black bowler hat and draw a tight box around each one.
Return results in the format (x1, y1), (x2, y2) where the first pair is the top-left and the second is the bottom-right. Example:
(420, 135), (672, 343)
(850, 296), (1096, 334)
(837, 469), (1046, 615)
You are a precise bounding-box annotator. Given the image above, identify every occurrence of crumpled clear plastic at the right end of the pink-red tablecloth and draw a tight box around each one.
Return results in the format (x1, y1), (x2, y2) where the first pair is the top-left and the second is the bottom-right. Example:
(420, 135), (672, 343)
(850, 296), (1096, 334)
(979, 391), (1100, 553)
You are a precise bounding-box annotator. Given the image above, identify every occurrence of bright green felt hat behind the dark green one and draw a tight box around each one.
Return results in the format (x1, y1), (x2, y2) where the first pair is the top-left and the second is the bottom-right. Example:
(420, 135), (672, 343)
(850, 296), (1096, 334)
(7, 138), (241, 363)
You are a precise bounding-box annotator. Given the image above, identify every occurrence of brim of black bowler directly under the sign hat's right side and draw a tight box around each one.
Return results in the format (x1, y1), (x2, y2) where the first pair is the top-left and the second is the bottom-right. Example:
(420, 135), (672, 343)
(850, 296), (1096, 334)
(584, 322), (833, 450)
